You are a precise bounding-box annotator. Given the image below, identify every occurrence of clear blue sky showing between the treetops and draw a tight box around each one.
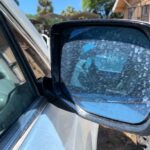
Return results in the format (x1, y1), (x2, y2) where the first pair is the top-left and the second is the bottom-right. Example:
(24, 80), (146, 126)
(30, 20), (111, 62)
(19, 0), (81, 14)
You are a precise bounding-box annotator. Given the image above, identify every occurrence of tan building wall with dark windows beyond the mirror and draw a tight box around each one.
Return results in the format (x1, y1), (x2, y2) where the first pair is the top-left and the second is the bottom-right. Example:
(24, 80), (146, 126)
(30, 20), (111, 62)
(123, 0), (150, 22)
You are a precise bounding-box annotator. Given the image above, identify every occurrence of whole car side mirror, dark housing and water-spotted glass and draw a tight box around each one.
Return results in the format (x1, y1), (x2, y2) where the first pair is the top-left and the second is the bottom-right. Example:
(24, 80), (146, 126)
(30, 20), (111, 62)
(51, 20), (150, 134)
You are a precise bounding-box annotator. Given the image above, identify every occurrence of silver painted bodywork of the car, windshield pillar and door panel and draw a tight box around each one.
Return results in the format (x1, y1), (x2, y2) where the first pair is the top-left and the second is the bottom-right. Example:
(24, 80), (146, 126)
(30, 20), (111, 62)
(0, 0), (98, 150)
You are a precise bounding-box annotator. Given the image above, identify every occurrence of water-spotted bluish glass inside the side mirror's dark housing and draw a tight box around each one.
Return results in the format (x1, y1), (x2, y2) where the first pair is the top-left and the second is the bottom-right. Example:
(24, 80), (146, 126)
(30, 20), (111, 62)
(61, 26), (150, 124)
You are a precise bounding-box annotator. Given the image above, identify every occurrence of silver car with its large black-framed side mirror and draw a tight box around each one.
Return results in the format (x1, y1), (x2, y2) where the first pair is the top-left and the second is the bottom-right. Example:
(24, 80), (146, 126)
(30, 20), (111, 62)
(0, 0), (150, 150)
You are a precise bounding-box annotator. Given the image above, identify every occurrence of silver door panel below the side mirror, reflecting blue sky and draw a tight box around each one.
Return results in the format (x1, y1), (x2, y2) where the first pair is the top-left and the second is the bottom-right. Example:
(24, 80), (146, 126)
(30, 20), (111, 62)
(20, 103), (98, 150)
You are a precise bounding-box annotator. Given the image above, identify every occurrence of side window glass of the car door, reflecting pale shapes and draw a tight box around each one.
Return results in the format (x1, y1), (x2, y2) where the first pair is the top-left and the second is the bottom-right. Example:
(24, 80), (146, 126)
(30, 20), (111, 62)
(0, 24), (37, 135)
